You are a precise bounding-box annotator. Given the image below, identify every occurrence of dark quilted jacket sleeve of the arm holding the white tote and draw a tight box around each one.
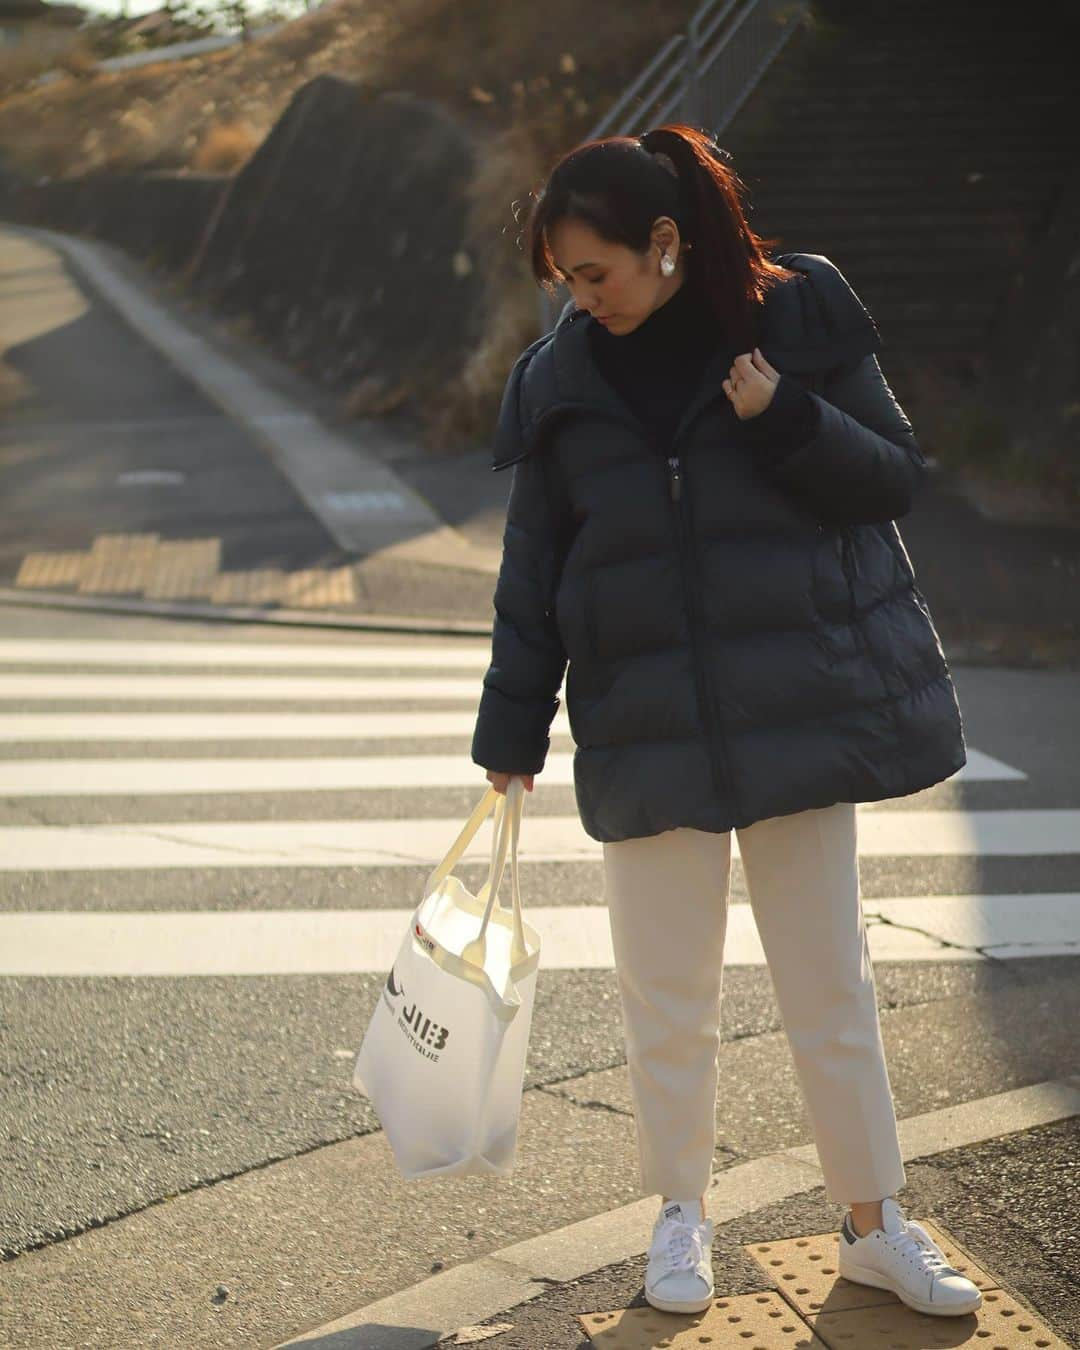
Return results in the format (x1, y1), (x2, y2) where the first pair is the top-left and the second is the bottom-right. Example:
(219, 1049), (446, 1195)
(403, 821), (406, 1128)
(473, 452), (567, 774)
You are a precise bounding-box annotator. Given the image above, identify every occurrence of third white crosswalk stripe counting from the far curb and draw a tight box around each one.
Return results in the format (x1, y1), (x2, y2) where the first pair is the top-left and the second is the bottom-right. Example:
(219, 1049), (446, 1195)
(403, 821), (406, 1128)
(0, 709), (572, 745)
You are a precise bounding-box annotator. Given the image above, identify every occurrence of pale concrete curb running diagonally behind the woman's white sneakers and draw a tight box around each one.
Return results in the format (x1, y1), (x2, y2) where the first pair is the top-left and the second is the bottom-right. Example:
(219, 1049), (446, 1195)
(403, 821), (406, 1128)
(274, 1076), (1080, 1350)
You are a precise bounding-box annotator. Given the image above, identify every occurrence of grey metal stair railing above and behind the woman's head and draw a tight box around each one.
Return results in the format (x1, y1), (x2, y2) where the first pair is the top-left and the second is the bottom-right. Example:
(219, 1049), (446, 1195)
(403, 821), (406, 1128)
(540, 0), (810, 333)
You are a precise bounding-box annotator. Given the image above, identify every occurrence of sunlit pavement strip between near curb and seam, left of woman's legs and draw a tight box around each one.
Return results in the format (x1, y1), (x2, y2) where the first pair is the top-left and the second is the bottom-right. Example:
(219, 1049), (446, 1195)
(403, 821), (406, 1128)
(0, 1069), (635, 1350)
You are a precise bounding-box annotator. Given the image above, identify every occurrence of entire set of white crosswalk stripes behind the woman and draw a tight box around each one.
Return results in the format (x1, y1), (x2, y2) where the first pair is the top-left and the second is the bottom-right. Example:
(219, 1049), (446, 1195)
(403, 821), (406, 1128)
(0, 639), (1063, 976)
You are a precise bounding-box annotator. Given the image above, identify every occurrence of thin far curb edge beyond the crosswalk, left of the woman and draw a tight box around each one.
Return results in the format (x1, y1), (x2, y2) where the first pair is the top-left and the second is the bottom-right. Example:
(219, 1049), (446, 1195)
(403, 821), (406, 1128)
(0, 586), (491, 637)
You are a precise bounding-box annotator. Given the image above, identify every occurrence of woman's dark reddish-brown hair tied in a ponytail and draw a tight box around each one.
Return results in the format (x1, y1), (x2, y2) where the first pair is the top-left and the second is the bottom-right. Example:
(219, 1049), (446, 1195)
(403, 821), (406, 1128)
(525, 123), (792, 351)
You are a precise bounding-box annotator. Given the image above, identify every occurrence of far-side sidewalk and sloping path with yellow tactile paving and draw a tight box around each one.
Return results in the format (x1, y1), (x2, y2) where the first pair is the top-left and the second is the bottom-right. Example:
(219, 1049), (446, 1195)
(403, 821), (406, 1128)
(0, 228), (496, 624)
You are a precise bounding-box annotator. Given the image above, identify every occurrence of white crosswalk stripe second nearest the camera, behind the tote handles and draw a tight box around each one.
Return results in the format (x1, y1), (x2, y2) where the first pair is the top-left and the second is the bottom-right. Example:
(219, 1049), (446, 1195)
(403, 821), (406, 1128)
(0, 810), (1080, 872)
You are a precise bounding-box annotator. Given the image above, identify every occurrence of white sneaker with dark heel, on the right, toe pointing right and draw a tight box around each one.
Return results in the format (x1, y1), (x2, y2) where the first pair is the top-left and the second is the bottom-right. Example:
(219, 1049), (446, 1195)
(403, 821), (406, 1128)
(840, 1196), (983, 1318)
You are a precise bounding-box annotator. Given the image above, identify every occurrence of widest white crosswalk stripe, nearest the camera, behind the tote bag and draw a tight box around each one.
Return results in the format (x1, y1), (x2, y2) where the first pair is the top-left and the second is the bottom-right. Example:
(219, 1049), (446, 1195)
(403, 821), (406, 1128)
(0, 892), (1080, 976)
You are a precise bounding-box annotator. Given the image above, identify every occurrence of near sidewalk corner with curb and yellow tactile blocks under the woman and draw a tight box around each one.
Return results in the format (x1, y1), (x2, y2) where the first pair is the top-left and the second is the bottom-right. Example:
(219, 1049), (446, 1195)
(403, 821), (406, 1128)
(272, 1077), (1080, 1350)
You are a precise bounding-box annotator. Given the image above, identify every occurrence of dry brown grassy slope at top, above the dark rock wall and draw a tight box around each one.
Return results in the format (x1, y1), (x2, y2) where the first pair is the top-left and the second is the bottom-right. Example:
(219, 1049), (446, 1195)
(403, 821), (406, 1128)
(0, 0), (693, 184)
